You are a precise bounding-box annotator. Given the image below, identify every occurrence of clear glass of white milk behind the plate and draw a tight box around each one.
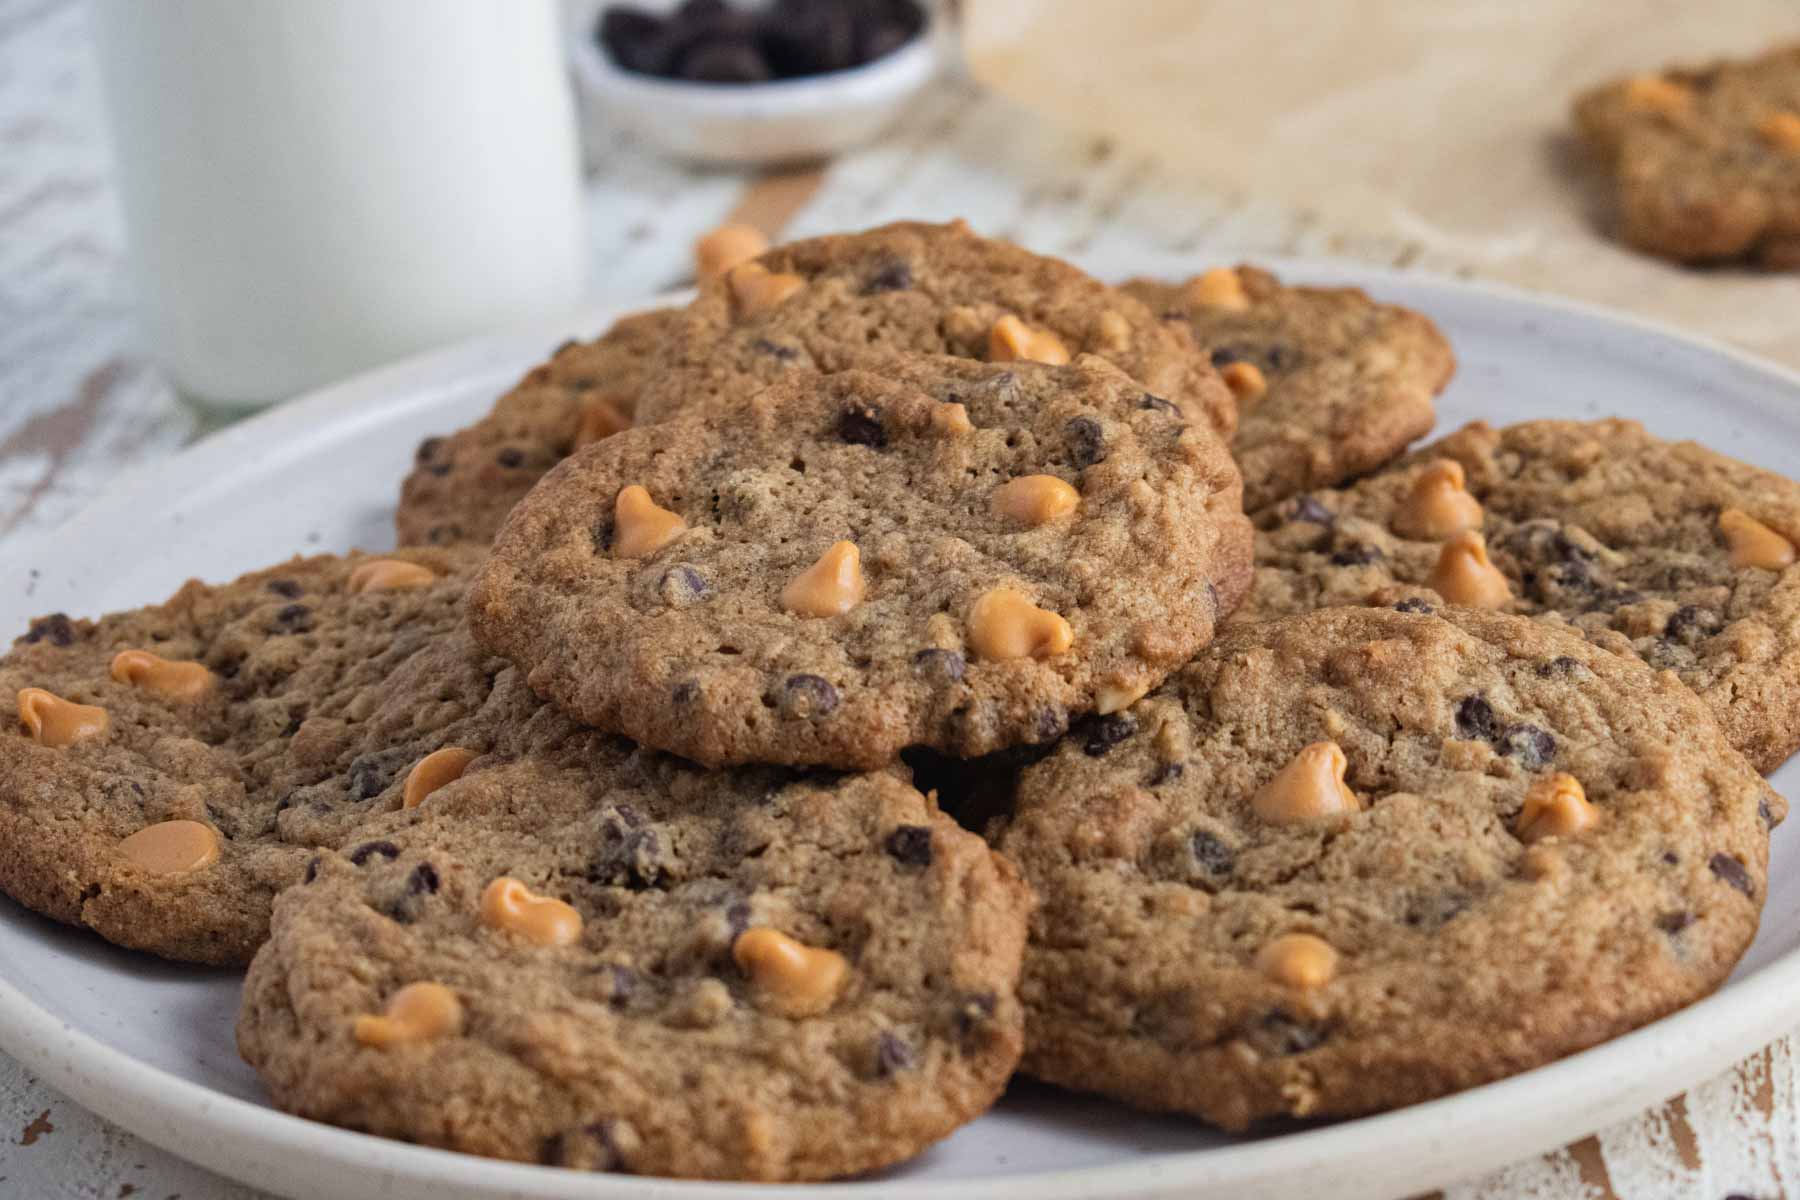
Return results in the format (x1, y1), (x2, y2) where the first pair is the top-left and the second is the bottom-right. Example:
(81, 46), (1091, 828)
(92, 0), (585, 410)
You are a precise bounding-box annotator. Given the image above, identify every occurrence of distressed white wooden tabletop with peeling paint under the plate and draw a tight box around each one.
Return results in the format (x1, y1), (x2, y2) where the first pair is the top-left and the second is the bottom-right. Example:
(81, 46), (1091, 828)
(0, 0), (1800, 1200)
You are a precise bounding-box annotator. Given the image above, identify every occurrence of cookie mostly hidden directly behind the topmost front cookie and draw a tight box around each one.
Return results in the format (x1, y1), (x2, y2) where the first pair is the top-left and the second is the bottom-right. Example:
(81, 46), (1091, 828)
(639, 221), (1235, 434)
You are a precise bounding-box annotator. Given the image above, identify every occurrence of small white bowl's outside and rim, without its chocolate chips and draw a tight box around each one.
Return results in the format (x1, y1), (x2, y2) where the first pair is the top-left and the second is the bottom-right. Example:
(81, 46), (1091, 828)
(571, 5), (940, 166)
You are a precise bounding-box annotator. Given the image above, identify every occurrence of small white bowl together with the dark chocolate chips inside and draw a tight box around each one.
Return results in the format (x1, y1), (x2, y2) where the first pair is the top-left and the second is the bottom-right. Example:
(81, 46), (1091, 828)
(571, 0), (938, 166)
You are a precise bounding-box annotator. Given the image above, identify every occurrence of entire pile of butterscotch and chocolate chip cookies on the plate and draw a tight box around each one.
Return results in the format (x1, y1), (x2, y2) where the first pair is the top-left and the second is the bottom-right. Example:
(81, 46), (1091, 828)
(0, 225), (1800, 1180)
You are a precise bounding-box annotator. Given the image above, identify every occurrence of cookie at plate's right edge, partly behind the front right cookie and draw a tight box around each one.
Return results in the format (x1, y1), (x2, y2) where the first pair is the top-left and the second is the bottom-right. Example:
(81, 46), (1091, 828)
(1233, 419), (1800, 770)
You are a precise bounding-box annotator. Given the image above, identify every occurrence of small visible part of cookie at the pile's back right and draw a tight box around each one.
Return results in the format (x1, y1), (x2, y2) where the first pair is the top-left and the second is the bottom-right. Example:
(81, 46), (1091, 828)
(1123, 266), (1456, 509)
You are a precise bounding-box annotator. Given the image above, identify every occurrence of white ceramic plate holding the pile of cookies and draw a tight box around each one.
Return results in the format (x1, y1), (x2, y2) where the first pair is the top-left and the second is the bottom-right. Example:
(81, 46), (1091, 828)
(0, 259), (1800, 1200)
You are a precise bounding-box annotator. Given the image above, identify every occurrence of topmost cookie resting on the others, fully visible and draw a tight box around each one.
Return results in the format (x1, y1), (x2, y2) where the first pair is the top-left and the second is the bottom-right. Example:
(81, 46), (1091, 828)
(470, 356), (1249, 766)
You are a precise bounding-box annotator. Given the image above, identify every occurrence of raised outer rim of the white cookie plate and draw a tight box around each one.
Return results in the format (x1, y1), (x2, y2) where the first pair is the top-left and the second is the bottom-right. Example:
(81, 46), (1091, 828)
(10, 264), (1800, 1200)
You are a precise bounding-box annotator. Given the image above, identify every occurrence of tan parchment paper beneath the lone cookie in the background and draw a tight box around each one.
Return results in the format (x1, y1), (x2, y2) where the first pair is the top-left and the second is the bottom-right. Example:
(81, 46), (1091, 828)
(965, 0), (1800, 365)
